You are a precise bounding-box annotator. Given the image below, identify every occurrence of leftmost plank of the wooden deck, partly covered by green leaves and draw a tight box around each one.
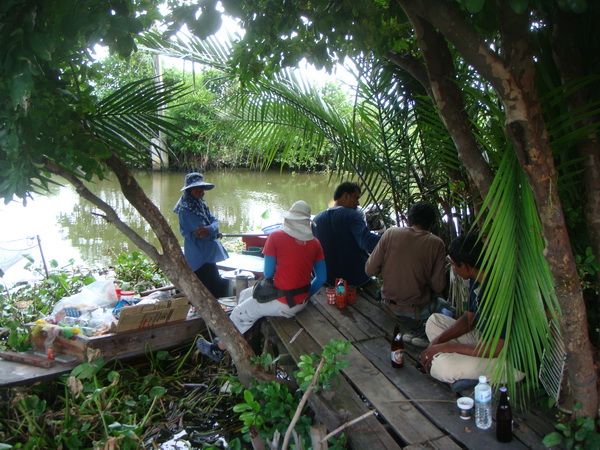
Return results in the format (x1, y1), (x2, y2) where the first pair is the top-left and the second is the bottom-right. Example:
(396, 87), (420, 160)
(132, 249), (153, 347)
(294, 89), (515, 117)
(269, 317), (400, 450)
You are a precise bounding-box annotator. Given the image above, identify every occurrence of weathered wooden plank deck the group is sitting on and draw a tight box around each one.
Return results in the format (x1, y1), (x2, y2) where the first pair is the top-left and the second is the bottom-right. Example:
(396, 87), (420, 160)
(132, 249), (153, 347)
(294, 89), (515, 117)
(263, 289), (553, 450)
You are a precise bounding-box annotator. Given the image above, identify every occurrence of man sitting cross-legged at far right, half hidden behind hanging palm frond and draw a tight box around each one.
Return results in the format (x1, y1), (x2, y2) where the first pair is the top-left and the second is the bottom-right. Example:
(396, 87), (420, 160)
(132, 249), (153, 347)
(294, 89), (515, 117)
(421, 234), (525, 384)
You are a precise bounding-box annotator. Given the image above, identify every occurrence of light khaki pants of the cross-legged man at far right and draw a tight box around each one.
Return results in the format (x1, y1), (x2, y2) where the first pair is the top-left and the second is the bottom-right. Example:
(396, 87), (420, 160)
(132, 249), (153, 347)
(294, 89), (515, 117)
(425, 314), (525, 383)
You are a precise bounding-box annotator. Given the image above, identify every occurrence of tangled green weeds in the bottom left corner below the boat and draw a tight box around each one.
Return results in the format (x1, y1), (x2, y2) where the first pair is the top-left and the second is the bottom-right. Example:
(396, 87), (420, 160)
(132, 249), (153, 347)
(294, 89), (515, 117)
(0, 349), (241, 450)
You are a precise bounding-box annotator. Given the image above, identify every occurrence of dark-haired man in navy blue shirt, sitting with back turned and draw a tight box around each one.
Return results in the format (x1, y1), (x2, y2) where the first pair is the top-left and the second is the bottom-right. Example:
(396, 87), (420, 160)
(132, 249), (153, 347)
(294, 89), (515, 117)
(313, 181), (380, 286)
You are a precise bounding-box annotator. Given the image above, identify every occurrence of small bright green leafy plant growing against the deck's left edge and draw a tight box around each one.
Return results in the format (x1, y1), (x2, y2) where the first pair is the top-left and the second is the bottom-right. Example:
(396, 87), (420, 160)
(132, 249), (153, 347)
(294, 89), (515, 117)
(233, 339), (351, 448)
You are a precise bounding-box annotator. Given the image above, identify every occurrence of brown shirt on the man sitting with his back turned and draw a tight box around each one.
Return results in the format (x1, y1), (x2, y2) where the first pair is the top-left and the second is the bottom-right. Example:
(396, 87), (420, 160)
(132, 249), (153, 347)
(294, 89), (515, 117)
(365, 227), (446, 309)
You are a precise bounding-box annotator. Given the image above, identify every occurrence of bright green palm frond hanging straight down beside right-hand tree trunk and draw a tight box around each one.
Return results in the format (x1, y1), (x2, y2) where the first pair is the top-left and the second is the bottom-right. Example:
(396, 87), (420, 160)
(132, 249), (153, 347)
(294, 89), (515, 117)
(481, 151), (558, 404)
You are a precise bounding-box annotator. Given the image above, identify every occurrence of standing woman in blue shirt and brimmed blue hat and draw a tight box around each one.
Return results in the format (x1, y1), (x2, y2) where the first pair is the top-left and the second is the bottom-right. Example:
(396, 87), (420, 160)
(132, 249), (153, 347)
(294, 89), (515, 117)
(173, 172), (229, 298)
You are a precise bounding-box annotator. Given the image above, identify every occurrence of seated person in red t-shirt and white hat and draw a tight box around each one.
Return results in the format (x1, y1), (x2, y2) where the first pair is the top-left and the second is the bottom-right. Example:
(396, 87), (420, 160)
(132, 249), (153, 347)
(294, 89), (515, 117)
(196, 200), (326, 362)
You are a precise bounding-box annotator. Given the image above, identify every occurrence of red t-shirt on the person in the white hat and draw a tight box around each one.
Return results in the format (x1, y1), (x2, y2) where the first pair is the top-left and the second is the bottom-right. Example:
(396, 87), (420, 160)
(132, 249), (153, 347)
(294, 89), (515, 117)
(263, 230), (325, 305)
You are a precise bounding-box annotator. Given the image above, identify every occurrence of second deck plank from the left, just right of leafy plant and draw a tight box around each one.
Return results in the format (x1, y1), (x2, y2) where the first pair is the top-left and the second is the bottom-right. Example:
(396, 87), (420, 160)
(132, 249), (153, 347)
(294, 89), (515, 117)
(296, 304), (444, 444)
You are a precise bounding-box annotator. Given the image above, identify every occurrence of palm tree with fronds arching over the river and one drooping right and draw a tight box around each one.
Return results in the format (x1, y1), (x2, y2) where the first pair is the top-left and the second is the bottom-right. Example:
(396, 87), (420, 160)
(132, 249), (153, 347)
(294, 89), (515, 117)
(144, 30), (557, 404)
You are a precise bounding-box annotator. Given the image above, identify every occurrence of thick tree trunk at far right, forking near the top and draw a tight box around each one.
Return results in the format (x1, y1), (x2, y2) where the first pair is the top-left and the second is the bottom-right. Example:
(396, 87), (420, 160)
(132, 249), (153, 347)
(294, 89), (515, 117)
(398, 0), (597, 417)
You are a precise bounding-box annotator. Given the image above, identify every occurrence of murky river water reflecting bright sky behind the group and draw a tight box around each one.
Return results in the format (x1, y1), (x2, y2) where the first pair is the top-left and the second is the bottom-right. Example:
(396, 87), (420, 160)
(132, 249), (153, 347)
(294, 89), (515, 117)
(0, 169), (338, 282)
